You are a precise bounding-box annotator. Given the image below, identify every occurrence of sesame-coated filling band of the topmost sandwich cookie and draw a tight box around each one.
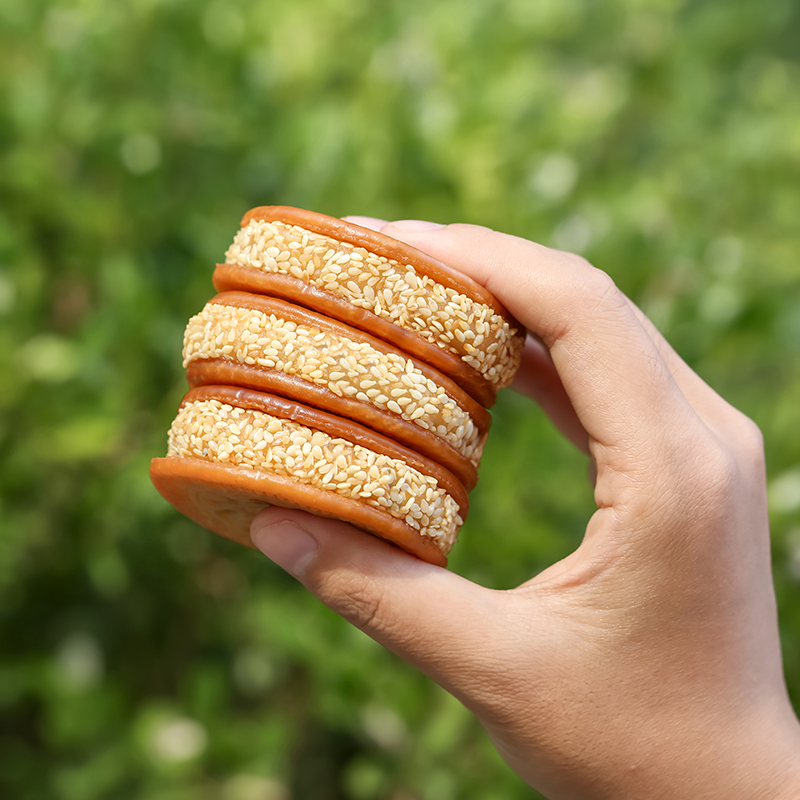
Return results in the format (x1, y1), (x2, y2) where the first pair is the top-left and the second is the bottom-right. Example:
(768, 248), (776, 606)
(225, 220), (520, 389)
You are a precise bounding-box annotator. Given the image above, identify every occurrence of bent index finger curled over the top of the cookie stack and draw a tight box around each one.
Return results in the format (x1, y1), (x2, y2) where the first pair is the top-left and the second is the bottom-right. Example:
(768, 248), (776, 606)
(382, 225), (700, 460)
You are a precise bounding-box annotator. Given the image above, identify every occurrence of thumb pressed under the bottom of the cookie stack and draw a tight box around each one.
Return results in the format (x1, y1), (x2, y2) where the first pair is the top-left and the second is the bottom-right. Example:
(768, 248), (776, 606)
(250, 507), (510, 705)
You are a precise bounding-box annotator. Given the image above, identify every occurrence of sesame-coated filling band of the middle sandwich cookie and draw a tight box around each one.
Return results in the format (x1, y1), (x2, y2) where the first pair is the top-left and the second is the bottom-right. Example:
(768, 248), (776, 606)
(183, 303), (484, 466)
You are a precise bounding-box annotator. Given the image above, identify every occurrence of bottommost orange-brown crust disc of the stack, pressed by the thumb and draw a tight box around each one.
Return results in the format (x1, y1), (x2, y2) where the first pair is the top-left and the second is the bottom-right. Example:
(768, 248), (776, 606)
(150, 456), (447, 567)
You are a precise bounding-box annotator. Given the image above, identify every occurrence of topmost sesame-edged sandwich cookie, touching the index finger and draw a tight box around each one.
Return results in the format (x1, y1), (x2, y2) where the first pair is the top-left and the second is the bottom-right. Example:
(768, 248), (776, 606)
(215, 206), (525, 406)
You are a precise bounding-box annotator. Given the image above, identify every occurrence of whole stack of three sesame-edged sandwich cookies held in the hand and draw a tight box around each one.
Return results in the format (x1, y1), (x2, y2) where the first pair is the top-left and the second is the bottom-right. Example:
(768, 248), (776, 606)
(150, 207), (525, 564)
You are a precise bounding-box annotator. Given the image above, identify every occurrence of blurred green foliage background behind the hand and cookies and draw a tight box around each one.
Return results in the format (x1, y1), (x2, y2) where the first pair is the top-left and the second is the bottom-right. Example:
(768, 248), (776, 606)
(0, 0), (800, 800)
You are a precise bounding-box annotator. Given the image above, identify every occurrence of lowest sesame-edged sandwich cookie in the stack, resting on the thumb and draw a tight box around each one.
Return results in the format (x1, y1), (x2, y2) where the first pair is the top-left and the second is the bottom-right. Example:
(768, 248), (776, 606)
(150, 386), (468, 565)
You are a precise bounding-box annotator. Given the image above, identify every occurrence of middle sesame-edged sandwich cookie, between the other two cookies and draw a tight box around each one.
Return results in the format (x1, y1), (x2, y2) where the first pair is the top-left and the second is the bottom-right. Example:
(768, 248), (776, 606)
(183, 292), (491, 491)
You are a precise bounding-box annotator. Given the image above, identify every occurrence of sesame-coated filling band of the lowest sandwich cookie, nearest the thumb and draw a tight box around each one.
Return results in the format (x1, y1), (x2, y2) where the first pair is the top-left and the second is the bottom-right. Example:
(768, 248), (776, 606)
(168, 400), (463, 552)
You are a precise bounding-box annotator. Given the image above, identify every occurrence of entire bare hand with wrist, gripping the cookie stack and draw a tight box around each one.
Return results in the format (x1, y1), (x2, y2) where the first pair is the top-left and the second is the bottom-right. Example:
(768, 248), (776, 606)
(251, 218), (800, 800)
